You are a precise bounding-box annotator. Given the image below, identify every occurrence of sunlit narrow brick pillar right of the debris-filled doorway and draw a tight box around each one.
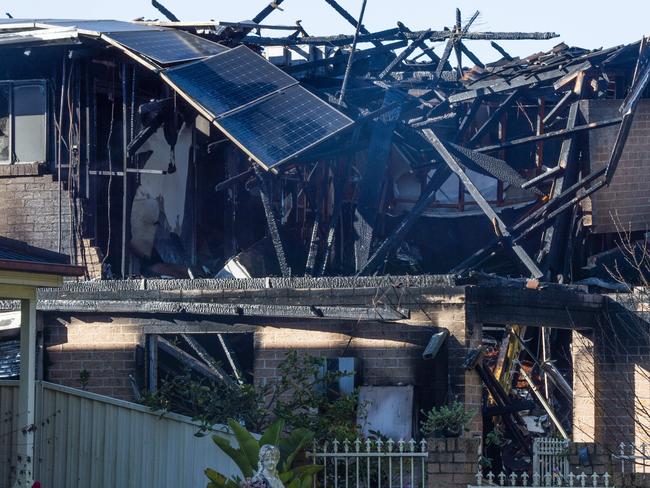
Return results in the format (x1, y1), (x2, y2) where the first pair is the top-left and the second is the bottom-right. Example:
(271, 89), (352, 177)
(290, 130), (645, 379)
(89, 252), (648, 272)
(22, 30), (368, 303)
(571, 331), (596, 442)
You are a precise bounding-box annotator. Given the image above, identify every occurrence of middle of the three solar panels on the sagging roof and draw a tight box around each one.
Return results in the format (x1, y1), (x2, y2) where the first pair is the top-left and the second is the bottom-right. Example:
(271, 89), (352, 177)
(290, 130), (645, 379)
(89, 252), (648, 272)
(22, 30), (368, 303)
(165, 46), (298, 117)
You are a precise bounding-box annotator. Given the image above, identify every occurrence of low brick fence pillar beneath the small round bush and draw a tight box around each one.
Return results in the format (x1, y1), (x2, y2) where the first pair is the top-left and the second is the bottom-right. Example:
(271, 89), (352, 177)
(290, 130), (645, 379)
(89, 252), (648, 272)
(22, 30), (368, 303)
(427, 438), (481, 488)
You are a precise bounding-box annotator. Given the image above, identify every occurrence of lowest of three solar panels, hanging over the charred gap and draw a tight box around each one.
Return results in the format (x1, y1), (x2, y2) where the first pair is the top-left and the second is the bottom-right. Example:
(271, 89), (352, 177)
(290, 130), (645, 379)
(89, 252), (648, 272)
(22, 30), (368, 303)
(217, 86), (353, 169)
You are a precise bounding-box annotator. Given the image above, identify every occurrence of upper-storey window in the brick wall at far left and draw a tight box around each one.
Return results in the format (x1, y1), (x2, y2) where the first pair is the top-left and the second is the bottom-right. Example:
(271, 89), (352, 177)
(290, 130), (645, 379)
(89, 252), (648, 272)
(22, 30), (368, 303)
(0, 81), (47, 164)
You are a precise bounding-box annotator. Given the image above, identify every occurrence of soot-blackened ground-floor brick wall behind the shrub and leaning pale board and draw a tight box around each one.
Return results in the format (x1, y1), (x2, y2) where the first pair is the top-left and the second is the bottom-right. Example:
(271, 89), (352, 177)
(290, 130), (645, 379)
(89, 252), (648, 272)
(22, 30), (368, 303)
(255, 302), (483, 436)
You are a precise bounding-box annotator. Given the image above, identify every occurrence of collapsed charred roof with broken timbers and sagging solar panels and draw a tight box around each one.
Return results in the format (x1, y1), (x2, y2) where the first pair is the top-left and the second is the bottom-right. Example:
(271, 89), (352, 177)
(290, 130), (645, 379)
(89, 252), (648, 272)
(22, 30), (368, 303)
(0, 0), (650, 281)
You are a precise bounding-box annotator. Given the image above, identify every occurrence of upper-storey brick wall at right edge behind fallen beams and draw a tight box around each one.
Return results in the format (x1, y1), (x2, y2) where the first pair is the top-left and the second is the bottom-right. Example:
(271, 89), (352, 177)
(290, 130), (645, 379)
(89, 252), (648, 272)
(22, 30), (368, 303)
(581, 100), (650, 233)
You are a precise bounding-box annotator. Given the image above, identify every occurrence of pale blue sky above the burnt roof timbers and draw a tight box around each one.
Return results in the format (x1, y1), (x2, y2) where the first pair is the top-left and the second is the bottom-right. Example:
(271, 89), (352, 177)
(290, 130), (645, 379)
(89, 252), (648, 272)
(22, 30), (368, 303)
(2, 0), (650, 61)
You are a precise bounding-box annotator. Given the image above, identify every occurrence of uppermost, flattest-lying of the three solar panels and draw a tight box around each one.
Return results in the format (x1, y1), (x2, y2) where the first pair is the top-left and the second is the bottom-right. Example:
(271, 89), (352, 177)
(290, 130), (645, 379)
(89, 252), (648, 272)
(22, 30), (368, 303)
(105, 30), (228, 64)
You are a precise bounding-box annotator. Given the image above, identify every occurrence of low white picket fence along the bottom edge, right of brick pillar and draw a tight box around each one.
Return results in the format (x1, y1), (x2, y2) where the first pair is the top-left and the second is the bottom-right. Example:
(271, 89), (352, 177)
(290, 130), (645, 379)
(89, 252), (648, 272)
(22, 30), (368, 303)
(468, 471), (612, 488)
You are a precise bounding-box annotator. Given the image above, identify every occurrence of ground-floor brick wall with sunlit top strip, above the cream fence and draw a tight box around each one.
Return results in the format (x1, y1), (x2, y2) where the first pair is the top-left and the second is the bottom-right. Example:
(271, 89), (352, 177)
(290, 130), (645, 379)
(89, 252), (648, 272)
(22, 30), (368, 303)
(43, 315), (142, 401)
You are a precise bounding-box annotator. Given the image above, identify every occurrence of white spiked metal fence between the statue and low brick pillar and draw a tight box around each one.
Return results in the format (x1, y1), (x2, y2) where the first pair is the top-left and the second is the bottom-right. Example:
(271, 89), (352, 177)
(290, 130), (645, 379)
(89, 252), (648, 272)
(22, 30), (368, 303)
(307, 439), (429, 488)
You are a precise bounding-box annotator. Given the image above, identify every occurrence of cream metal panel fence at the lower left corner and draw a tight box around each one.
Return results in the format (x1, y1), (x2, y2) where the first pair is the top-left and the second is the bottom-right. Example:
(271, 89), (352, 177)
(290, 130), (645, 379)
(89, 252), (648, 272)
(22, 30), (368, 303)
(0, 381), (240, 488)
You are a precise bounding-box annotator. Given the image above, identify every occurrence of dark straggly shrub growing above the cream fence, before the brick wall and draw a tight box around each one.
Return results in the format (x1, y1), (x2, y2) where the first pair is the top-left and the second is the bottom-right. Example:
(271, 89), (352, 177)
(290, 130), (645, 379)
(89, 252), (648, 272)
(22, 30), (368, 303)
(142, 351), (365, 441)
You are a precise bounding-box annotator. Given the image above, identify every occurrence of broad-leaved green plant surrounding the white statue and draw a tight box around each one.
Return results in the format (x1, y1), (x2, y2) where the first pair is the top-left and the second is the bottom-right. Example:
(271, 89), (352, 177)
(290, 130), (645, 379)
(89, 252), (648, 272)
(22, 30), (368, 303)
(205, 419), (322, 488)
